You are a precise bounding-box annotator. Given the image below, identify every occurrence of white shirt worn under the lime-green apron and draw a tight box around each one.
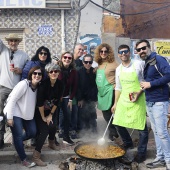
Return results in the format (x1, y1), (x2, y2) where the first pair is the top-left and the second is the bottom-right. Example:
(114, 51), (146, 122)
(115, 60), (145, 91)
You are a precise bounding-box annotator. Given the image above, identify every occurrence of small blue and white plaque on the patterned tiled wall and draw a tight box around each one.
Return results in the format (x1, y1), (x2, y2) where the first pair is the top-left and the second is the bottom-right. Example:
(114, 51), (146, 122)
(38, 24), (54, 36)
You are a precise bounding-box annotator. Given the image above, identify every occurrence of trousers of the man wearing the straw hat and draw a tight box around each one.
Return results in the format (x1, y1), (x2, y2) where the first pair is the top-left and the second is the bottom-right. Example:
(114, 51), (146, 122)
(0, 86), (12, 140)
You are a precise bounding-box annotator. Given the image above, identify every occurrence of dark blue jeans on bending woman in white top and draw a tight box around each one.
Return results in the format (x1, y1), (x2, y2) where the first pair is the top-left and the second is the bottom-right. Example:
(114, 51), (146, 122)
(10, 116), (36, 161)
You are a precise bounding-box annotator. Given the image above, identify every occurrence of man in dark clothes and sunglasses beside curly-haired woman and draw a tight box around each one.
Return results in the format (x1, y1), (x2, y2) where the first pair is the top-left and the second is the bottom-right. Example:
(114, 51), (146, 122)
(77, 54), (97, 133)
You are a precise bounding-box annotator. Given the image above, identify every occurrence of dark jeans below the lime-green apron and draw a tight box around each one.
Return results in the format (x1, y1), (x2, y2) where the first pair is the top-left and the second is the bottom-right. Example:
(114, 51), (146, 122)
(116, 125), (148, 156)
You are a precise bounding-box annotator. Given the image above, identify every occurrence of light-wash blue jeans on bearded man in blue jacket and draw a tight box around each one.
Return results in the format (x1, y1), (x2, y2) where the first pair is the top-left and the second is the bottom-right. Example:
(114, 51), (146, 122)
(146, 101), (170, 163)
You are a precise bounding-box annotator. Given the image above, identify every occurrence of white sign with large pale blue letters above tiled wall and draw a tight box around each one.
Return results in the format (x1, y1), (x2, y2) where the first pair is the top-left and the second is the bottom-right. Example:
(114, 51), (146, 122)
(0, 0), (46, 8)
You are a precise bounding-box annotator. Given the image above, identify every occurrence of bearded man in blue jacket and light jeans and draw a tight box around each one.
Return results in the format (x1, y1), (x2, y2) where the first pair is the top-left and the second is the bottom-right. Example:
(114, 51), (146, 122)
(136, 40), (170, 170)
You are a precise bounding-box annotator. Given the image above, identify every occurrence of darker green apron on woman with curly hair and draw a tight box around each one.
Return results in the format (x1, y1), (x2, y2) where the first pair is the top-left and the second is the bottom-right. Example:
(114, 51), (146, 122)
(96, 64), (113, 110)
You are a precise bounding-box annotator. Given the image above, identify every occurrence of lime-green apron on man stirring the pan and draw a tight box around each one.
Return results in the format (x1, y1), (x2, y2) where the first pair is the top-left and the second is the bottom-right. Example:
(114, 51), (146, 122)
(113, 65), (146, 130)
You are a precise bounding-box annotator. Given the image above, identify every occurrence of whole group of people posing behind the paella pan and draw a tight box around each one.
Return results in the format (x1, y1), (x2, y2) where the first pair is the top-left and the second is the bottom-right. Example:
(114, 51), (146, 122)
(0, 34), (170, 170)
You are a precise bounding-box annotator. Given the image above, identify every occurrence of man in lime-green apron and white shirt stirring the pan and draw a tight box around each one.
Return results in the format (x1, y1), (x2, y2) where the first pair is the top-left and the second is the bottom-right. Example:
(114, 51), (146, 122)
(112, 45), (148, 163)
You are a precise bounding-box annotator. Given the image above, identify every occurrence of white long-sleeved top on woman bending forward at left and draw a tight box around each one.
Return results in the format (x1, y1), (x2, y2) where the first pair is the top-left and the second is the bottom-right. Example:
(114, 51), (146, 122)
(3, 79), (37, 120)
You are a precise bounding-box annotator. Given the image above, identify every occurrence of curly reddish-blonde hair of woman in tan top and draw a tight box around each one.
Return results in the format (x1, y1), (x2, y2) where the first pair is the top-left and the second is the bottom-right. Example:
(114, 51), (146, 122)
(94, 43), (115, 65)
